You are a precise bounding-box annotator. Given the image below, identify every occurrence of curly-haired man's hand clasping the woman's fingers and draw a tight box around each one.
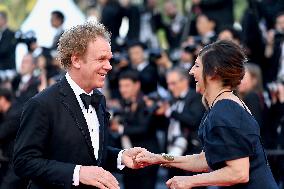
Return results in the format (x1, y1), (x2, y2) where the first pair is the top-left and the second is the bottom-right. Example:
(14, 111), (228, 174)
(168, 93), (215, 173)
(121, 147), (147, 169)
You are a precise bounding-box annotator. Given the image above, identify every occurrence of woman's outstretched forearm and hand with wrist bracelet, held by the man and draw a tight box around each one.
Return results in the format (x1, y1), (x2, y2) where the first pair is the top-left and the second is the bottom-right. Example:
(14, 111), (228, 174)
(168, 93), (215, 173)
(136, 152), (209, 172)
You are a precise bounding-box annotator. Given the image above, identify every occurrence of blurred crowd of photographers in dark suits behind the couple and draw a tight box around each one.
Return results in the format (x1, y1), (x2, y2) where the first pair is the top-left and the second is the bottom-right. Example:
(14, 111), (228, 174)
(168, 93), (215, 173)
(0, 0), (284, 189)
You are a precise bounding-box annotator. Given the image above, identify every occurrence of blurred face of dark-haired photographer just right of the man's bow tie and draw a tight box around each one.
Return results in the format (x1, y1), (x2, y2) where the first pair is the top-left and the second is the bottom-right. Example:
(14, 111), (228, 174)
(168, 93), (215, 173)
(119, 79), (140, 100)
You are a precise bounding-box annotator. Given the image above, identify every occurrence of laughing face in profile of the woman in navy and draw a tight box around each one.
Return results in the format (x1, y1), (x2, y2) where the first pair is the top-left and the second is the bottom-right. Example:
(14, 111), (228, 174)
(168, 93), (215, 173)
(189, 57), (205, 94)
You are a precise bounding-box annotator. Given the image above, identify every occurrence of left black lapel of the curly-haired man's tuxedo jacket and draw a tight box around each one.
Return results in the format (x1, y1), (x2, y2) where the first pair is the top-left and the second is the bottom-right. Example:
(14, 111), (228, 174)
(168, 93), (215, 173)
(59, 77), (96, 160)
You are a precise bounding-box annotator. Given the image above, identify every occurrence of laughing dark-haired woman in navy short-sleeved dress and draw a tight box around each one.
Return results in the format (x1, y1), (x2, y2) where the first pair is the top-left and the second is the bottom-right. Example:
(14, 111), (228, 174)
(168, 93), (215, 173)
(136, 41), (278, 189)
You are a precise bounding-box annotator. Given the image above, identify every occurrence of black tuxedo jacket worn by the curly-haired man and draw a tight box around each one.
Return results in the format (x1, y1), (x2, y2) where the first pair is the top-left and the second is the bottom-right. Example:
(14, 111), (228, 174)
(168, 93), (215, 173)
(14, 77), (119, 189)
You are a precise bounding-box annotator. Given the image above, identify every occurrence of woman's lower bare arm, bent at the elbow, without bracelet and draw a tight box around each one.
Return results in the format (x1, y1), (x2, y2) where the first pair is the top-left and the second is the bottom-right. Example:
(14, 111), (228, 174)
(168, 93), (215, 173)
(167, 157), (250, 189)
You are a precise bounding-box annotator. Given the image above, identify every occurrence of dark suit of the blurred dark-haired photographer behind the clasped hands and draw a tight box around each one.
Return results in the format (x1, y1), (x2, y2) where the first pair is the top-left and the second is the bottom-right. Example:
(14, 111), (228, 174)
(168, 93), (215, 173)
(119, 94), (160, 189)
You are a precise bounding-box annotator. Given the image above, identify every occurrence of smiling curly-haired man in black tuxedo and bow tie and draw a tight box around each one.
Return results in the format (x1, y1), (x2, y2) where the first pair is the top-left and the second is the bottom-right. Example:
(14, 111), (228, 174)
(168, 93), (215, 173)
(14, 22), (141, 189)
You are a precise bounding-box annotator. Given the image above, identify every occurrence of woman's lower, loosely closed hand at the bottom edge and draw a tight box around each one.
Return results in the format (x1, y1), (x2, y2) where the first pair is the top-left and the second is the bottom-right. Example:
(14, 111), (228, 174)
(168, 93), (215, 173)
(166, 176), (193, 189)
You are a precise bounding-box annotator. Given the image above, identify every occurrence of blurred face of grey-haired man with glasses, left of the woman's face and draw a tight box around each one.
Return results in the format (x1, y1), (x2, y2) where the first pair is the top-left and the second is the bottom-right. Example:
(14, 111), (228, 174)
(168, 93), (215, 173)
(167, 72), (188, 97)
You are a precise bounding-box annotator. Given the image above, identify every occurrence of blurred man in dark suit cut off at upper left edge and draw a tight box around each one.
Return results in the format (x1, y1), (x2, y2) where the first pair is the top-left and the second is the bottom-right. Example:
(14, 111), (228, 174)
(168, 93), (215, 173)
(0, 11), (16, 70)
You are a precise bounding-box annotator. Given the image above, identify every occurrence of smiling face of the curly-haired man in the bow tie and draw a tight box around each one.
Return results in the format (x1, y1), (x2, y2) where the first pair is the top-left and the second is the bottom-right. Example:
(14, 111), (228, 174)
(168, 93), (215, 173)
(72, 37), (112, 92)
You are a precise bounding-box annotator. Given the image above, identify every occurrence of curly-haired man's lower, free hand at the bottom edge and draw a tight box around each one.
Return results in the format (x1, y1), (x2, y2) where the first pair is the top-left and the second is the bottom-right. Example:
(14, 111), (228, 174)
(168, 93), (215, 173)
(80, 166), (119, 189)
